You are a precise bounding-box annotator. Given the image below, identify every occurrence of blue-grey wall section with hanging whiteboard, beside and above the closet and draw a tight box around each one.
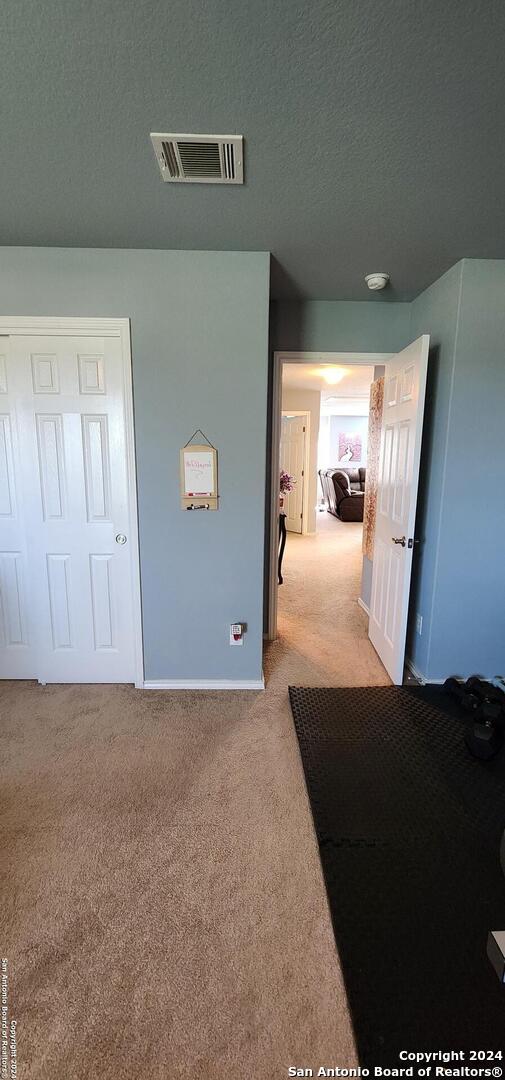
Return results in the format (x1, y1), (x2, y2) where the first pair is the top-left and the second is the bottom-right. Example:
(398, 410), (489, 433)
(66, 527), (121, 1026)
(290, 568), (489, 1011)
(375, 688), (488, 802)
(0, 247), (270, 679)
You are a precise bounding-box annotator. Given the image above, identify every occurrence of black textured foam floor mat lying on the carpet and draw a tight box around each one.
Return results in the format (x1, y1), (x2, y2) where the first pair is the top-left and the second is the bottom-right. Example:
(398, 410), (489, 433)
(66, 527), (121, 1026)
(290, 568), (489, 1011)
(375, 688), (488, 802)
(289, 687), (505, 1067)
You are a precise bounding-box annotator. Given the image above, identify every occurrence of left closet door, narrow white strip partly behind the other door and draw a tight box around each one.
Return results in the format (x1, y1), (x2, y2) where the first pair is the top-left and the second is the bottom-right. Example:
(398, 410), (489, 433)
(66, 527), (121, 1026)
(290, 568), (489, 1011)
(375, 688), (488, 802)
(0, 337), (37, 678)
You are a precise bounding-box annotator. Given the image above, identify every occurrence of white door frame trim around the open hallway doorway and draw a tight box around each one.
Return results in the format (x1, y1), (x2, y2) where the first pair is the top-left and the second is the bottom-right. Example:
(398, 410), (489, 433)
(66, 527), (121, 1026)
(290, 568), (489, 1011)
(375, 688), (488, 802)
(265, 349), (395, 642)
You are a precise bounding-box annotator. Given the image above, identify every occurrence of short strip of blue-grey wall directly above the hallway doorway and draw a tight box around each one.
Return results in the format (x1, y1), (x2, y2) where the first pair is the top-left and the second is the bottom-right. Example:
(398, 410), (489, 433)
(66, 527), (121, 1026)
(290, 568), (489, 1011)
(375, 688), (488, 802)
(272, 300), (410, 352)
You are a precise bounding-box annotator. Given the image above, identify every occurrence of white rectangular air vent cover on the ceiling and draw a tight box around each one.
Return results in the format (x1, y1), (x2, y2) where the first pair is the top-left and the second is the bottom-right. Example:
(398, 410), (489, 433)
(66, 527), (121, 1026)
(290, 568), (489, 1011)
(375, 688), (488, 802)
(151, 132), (244, 184)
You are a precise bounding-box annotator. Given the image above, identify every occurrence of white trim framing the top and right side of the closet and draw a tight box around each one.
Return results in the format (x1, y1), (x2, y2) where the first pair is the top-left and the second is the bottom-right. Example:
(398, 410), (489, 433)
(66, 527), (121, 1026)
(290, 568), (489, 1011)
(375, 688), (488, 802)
(0, 315), (144, 689)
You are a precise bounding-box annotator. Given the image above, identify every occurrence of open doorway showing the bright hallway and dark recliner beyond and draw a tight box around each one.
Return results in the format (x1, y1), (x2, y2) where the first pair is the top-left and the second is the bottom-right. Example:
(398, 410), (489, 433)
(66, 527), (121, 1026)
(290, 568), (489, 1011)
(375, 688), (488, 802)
(269, 354), (388, 683)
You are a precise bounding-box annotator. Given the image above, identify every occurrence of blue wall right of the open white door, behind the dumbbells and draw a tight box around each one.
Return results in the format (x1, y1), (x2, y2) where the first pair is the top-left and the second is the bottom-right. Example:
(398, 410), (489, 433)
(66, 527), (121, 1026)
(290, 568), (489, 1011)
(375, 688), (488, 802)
(410, 259), (505, 679)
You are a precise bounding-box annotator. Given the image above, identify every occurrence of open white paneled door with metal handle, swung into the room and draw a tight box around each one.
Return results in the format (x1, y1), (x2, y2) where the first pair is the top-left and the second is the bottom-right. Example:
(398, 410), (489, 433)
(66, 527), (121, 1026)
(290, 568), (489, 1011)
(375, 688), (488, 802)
(368, 334), (429, 686)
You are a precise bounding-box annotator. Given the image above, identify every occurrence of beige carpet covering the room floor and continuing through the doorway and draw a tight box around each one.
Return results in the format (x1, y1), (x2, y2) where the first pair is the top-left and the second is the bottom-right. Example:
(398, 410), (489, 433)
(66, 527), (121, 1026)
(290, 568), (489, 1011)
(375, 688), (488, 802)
(0, 515), (387, 1080)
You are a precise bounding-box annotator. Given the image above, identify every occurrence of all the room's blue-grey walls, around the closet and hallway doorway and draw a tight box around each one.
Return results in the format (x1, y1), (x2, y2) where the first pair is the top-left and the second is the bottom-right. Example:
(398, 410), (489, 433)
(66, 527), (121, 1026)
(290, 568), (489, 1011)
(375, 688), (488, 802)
(0, 247), (505, 679)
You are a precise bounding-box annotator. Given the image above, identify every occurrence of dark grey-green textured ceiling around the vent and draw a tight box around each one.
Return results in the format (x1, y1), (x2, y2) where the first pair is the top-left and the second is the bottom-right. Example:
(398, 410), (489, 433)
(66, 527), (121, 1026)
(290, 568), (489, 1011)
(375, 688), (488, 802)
(0, 0), (505, 302)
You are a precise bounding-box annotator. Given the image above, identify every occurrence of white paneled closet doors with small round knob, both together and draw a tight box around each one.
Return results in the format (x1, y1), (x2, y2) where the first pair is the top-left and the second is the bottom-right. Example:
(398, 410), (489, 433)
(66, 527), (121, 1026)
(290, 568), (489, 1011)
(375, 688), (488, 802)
(0, 334), (139, 683)
